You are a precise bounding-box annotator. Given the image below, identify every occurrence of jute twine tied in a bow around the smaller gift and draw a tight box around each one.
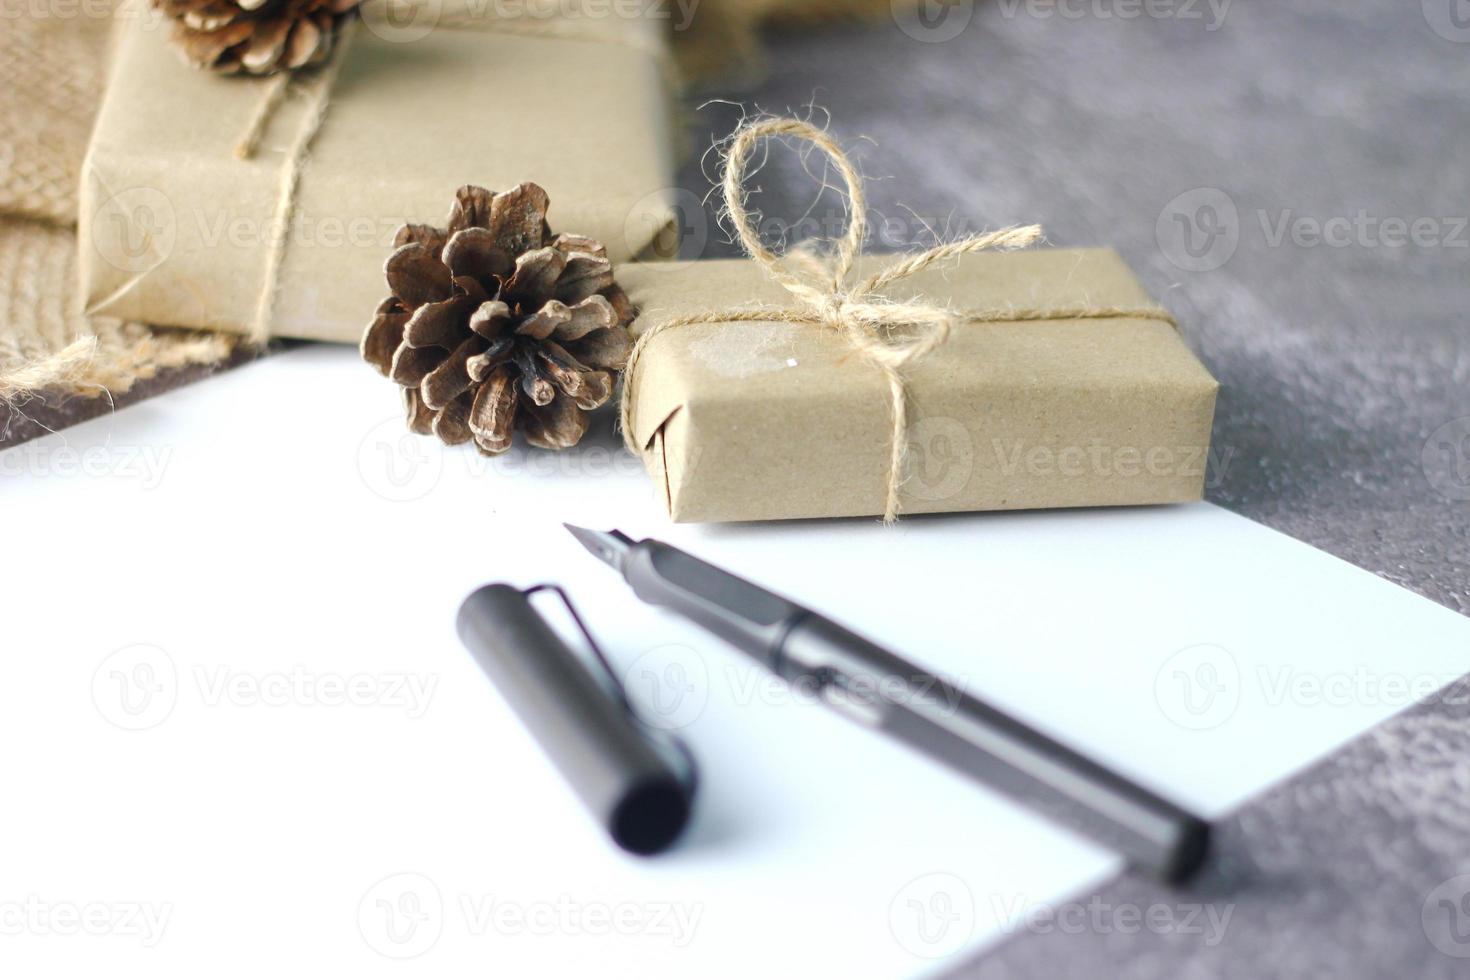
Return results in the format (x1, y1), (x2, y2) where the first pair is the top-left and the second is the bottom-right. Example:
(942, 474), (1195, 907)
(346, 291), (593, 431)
(620, 119), (1175, 523)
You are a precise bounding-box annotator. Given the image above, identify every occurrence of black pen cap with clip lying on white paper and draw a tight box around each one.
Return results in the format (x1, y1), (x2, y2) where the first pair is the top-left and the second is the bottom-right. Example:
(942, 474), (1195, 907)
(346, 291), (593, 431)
(457, 585), (694, 854)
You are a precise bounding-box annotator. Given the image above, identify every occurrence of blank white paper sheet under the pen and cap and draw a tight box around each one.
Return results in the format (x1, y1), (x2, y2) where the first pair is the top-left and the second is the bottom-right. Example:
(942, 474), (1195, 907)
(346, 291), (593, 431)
(0, 348), (1470, 979)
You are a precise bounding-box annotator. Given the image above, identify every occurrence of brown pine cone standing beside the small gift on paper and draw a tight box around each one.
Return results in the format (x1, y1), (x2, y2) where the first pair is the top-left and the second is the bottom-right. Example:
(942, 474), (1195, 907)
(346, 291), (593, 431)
(362, 184), (634, 455)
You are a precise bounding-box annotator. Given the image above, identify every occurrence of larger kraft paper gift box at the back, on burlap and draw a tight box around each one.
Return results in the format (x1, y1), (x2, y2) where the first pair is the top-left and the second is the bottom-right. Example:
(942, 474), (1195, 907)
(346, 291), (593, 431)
(79, 0), (676, 342)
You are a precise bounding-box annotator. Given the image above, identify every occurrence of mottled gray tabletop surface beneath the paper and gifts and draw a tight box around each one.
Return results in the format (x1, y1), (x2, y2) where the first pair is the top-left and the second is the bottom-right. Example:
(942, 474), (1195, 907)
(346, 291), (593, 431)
(0, 0), (1470, 980)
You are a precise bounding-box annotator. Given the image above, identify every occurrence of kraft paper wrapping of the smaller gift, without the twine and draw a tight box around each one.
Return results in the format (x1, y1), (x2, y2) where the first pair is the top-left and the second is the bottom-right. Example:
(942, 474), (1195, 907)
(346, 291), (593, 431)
(619, 248), (1219, 522)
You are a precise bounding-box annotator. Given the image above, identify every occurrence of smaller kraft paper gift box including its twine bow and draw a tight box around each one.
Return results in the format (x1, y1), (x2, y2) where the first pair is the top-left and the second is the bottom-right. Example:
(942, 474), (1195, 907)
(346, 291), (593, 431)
(622, 118), (1219, 522)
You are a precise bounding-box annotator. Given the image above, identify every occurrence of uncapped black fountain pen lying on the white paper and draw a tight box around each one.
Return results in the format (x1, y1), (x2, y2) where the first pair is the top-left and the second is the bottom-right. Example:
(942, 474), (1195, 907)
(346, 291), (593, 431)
(566, 525), (1210, 882)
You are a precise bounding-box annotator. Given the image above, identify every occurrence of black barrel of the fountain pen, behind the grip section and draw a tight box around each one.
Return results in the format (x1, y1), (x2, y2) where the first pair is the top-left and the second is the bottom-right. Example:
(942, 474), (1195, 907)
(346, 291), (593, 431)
(778, 617), (1208, 882)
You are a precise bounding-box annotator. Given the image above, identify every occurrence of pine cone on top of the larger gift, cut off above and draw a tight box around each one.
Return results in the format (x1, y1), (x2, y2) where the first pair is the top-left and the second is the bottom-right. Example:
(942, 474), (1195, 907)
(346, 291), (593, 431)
(151, 0), (362, 75)
